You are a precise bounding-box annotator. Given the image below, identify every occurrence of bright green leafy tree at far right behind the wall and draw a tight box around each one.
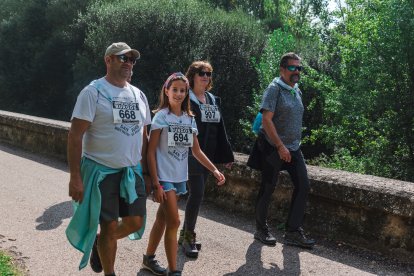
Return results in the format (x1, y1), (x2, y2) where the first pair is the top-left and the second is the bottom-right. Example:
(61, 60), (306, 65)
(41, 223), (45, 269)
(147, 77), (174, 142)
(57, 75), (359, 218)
(315, 0), (414, 181)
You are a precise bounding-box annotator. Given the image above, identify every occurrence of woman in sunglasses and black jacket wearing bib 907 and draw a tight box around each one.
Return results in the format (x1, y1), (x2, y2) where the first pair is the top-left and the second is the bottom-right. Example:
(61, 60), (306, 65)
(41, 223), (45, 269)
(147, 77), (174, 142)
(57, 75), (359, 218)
(179, 61), (234, 258)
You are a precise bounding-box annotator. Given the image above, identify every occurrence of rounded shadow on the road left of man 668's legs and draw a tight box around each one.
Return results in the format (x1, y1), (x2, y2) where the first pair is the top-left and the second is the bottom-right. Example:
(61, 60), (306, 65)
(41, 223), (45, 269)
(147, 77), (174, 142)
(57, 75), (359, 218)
(36, 201), (73, 231)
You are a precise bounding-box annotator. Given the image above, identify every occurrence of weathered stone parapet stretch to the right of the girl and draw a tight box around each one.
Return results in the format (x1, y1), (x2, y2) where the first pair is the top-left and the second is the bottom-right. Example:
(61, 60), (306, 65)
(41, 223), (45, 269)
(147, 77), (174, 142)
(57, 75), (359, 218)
(210, 154), (414, 262)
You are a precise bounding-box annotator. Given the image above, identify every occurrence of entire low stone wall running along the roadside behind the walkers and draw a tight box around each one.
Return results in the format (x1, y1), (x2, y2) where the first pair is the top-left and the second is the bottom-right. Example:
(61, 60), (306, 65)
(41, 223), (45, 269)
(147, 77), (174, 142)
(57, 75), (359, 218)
(0, 111), (414, 261)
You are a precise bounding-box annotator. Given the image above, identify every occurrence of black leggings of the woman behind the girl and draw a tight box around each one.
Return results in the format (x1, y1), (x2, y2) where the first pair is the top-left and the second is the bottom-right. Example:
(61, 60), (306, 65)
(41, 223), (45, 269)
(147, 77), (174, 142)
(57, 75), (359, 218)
(183, 171), (208, 232)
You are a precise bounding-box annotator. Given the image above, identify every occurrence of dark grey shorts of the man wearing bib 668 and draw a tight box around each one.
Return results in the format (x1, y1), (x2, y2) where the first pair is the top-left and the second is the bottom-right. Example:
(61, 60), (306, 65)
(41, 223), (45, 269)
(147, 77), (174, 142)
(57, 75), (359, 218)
(99, 172), (147, 222)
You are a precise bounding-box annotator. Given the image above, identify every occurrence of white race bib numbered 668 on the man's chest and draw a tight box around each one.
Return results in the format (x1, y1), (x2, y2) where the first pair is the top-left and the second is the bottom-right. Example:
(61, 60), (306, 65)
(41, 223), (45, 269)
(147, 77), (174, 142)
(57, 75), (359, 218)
(112, 101), (142, 124)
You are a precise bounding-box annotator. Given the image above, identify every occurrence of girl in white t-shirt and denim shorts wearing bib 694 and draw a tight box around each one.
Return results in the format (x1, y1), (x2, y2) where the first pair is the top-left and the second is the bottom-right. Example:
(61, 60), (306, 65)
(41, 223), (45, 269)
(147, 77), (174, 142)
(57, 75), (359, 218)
(143, 73), (225, 275)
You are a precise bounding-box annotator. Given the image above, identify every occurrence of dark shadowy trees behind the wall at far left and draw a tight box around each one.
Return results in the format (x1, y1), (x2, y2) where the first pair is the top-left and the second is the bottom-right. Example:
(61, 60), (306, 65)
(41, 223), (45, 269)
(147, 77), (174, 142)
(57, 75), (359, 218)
(0, 0), (93, 119)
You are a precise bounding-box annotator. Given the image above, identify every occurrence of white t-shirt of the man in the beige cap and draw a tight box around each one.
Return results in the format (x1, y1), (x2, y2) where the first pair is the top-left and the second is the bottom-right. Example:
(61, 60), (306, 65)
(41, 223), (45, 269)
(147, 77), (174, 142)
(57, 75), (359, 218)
(71, 78), (151, 168)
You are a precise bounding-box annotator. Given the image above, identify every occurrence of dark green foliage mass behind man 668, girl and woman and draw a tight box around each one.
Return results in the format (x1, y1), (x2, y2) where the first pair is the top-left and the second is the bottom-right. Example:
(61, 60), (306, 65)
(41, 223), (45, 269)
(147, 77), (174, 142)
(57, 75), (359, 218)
(0, 0), (265, 151)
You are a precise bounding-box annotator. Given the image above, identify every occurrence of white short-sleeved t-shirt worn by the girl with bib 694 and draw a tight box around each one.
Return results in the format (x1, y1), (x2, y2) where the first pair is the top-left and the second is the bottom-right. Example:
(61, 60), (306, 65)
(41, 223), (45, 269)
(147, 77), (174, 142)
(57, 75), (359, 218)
(151, 108), (198, 183)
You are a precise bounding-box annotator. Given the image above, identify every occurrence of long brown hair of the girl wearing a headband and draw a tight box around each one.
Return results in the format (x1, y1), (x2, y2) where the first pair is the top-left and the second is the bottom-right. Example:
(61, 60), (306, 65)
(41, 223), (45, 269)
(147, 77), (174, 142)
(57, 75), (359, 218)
(152, 72), (194, 116)
